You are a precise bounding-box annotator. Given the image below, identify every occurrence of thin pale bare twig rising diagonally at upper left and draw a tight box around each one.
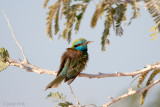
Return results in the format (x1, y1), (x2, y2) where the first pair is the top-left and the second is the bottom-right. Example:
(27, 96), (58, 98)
(2, 10), (28, 63)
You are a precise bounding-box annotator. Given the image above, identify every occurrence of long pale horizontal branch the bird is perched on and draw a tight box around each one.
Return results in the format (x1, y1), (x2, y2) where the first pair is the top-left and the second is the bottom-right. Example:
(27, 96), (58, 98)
(9, 59), (160, 79)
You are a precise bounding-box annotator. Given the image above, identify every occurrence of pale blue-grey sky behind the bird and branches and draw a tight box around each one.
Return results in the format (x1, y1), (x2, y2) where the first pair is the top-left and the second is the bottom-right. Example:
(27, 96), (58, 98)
(0, 0), (160, 107)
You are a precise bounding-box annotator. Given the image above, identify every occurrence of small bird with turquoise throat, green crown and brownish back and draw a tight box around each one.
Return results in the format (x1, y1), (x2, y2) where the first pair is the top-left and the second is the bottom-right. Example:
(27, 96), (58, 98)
(46, 38), (93, 90)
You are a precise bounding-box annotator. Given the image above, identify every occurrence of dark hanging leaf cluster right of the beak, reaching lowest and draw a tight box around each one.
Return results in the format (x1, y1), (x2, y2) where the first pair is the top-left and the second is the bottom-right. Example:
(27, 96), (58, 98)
(101, 4), (127, 51)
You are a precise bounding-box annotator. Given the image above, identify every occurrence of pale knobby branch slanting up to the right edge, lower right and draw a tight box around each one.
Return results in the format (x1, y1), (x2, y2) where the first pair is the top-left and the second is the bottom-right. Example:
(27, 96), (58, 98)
(103, 79), (160, 107)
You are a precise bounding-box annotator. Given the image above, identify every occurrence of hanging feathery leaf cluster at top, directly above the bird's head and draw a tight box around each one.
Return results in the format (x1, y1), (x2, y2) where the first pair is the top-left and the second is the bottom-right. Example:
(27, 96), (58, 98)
(44, 0), (89, 42)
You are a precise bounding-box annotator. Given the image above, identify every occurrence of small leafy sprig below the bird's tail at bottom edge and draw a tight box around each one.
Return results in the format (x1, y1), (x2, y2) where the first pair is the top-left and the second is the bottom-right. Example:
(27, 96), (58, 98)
(47, 92), (73, 107)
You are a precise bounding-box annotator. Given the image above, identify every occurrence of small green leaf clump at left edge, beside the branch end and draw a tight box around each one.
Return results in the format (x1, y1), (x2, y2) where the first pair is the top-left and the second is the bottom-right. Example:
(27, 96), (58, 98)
(0, 47), (9, 72)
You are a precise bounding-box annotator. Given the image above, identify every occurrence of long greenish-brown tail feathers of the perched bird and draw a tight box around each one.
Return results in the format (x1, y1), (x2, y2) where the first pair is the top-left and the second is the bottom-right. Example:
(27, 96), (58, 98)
(46, 75), (65, 90)
